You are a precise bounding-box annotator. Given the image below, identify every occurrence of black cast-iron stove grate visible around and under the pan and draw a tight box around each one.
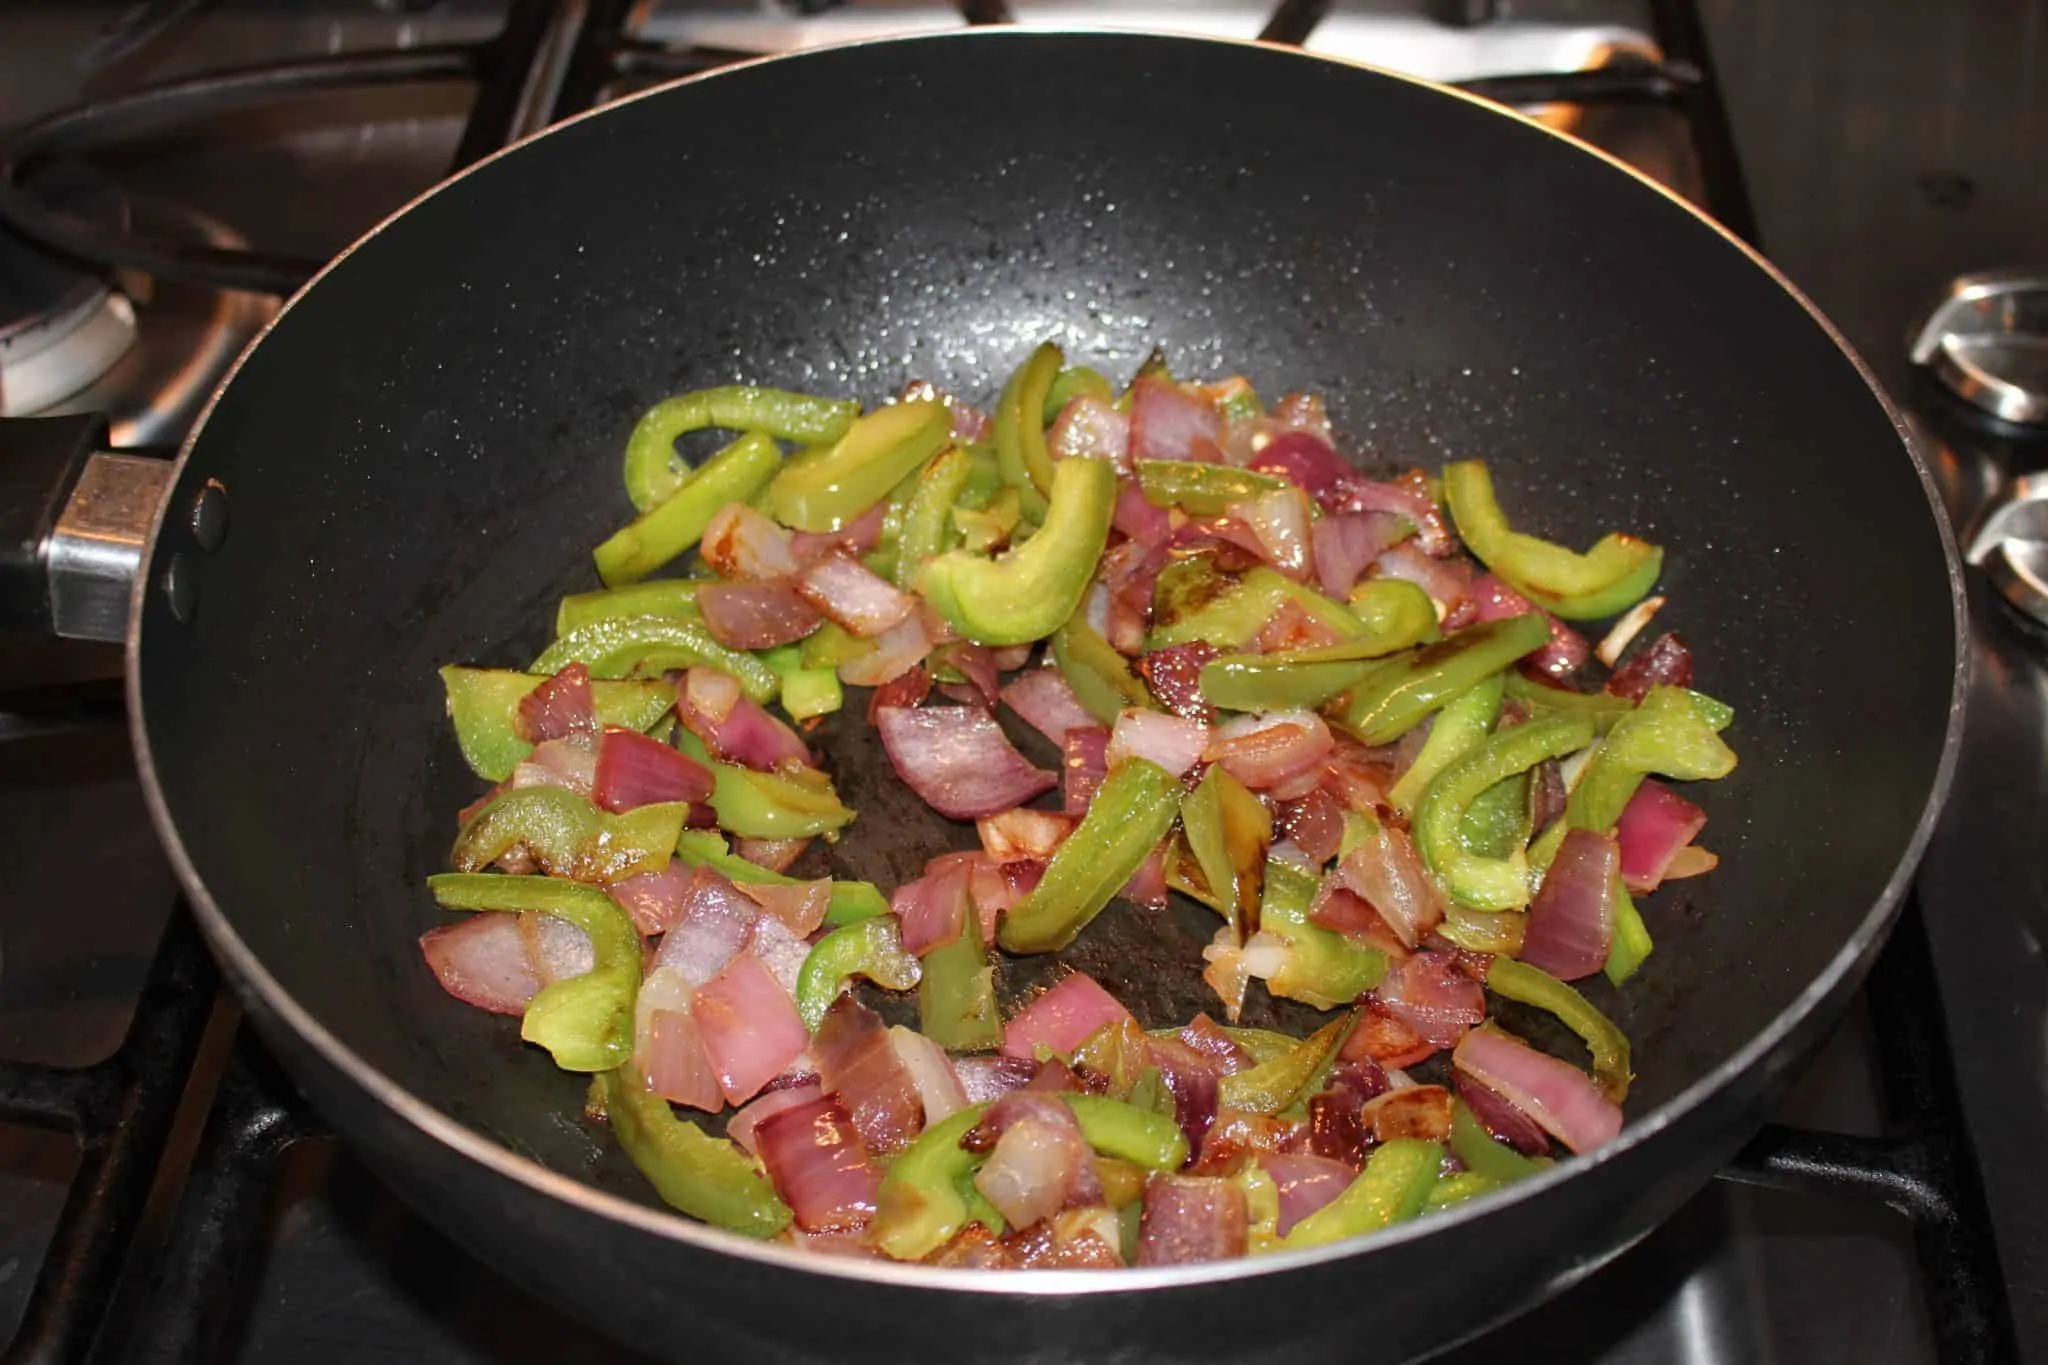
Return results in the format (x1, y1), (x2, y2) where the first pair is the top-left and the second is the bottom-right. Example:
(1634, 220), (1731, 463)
(0, 0), (2017, 1365)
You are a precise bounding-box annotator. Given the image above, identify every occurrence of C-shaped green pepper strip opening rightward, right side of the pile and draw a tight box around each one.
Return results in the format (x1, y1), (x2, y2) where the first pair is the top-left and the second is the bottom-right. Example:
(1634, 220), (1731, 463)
(1415, 712), (1593, 911)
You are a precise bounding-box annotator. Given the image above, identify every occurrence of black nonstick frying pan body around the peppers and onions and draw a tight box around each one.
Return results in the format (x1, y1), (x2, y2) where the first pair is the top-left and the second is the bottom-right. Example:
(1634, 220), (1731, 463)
(103, 33), (1964, 1361)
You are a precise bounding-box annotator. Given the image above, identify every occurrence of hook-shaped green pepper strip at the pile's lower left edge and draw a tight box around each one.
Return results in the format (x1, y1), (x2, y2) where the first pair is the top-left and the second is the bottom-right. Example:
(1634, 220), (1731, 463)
(426, 872), (641, 1070)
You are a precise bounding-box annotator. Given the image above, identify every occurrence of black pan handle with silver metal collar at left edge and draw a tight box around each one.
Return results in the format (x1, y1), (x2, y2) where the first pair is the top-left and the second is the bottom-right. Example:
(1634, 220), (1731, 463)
(0, 415), (170, 641)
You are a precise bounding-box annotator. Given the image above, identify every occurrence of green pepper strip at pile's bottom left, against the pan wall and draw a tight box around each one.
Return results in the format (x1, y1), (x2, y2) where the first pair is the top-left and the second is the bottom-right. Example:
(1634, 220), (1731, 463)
(590, 1068), (791, 1238)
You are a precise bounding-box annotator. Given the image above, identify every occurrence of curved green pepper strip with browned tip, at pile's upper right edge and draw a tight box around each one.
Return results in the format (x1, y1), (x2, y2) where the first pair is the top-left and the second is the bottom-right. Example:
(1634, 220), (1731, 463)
(1444, 460), (1663, 620)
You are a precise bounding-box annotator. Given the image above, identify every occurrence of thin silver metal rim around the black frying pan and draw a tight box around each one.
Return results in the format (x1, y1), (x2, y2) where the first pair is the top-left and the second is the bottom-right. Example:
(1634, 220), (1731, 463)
(125, 27), (1972, 1301)
